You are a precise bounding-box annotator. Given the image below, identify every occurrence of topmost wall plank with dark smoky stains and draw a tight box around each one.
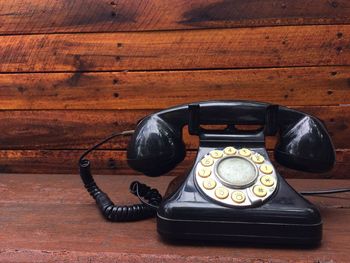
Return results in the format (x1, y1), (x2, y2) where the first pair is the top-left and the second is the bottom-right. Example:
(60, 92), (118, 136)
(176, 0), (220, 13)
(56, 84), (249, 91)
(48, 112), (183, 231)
(0, 0), (350, 34)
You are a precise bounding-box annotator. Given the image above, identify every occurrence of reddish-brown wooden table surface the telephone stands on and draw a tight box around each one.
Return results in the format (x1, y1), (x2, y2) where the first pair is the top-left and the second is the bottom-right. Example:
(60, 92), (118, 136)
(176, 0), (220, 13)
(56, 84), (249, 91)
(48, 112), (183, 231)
(0, 174), (350, 263)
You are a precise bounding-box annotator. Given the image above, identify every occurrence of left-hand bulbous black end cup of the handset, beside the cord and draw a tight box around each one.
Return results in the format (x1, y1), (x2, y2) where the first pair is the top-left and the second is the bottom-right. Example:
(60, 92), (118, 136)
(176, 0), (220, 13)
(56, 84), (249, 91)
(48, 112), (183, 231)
(127, 114), (186, 176)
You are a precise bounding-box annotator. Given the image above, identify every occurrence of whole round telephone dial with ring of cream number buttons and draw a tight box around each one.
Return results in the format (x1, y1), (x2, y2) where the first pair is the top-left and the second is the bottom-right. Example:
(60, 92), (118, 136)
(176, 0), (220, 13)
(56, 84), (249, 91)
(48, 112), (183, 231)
(195, 146), (277, 207)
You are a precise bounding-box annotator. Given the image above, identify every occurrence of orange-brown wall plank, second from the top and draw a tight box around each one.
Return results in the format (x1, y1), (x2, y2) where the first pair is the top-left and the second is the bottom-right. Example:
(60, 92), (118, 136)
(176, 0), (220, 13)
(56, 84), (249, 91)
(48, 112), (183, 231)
(0, 25), (350, 72)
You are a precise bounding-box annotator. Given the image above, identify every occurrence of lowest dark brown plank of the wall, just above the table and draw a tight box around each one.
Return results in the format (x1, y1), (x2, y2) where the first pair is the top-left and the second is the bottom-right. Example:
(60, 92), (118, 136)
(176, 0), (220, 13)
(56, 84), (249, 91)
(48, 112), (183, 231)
(0, 150), (350, 179)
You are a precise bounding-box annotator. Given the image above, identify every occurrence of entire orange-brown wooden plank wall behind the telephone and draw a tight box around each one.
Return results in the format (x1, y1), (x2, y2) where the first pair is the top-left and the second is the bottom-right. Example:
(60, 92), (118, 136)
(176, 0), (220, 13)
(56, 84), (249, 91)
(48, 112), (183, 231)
(0, 0), (350, 178)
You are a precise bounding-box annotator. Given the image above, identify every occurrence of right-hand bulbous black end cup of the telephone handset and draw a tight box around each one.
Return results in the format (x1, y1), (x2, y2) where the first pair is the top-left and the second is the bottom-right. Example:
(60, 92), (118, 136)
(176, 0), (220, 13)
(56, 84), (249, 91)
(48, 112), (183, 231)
(275, 107), (335, 172)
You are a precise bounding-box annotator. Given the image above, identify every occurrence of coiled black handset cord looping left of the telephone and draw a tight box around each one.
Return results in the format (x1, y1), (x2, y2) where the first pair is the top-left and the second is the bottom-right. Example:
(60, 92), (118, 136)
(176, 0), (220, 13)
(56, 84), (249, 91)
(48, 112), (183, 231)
(79, 131), (162, 222)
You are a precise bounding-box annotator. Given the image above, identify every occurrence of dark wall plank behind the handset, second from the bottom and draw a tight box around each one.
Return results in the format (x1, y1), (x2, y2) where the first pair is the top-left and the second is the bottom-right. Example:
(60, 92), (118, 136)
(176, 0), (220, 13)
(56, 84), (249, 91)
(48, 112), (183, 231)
(0, 105), (350, 150)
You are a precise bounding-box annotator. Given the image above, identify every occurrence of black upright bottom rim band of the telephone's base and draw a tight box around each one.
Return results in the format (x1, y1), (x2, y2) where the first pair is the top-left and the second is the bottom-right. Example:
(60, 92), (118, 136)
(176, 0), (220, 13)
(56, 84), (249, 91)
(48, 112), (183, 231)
(157, 215), (322, 247)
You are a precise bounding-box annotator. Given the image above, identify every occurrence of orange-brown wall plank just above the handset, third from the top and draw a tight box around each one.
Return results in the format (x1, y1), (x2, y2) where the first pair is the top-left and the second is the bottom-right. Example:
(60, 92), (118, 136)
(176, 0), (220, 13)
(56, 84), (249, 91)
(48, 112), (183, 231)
(0, 66), (350, 110)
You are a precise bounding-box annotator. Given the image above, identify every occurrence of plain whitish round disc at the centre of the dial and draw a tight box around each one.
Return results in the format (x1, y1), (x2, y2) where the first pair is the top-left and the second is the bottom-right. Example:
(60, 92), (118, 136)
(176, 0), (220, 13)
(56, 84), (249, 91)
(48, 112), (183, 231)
(217, 157), (257, 187)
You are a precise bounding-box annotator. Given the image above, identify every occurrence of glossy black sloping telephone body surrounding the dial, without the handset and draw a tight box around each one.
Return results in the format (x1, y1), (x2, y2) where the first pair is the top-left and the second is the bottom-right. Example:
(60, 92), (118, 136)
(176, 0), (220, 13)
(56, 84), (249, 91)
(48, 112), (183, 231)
(157, 147), (322, 247)
